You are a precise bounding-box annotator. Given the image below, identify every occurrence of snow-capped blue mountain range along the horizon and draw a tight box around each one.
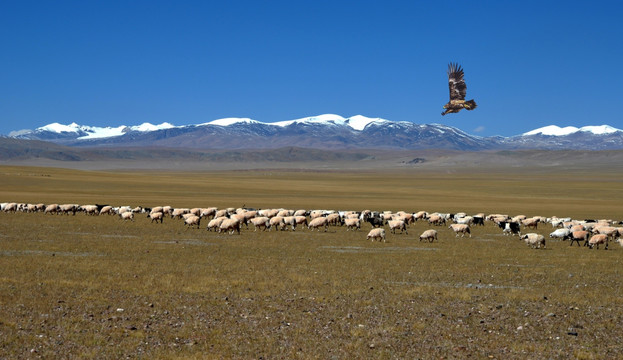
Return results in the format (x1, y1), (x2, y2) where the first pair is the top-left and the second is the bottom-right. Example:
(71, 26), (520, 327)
(4, 114), (623, 150)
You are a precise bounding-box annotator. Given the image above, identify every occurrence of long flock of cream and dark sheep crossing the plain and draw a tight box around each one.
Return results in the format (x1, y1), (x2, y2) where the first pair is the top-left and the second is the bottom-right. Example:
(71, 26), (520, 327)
(0, 202), (623, 249)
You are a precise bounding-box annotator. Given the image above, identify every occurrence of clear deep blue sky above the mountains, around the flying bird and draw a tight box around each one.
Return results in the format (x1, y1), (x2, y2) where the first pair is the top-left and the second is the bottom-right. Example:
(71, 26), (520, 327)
(0, 0), (623, 136)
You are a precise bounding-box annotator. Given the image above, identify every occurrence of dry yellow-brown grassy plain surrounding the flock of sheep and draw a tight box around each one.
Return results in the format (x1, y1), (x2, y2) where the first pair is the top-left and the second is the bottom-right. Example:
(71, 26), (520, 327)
(0, 166), (623, 359)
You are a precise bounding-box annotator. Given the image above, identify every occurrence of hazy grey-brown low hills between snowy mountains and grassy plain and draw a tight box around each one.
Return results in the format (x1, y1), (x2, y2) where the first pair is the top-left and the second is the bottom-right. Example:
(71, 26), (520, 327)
(0, 138), (623, 174)
